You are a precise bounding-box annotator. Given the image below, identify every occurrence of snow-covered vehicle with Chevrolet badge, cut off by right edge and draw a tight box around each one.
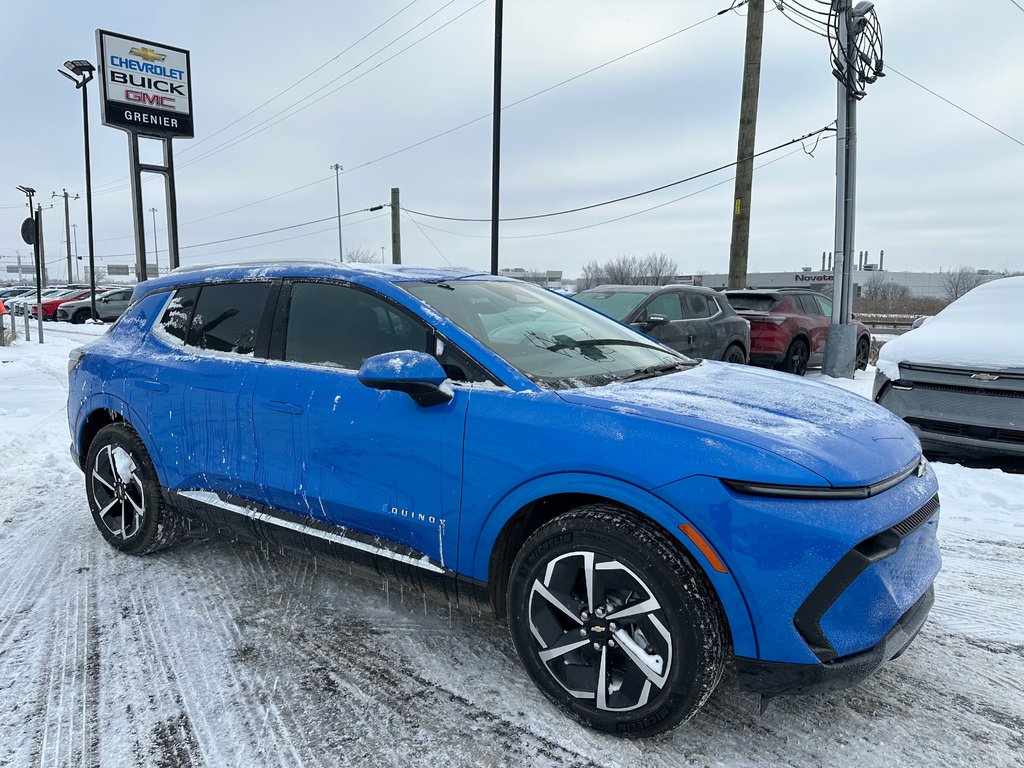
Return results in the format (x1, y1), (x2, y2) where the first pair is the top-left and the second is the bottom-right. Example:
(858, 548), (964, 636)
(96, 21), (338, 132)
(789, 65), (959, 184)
(874, 278), (1024, 458)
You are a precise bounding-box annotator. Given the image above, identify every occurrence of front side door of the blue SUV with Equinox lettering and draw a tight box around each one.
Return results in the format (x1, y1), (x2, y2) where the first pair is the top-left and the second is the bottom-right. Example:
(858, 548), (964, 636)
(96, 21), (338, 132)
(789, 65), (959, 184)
(254, 281), (469, 567)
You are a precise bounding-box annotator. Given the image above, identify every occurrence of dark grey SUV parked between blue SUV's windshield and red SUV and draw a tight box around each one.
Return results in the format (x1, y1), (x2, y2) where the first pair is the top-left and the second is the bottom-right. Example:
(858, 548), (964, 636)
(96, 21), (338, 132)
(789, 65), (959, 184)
(573, 286), (751, 362)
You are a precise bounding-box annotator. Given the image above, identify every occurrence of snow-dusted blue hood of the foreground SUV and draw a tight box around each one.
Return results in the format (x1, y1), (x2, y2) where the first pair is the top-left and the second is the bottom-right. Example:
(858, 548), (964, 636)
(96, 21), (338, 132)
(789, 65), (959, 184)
(559, 361), (921, 485)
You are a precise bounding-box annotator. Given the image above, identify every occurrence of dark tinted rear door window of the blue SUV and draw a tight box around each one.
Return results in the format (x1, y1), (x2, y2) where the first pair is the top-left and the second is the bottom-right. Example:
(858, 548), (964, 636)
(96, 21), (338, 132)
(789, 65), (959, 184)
(185, 283), (270, 354)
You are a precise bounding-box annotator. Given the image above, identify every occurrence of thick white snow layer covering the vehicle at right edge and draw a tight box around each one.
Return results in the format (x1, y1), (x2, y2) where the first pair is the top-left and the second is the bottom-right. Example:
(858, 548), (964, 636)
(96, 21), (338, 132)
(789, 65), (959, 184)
(879, 276), (1024, 381)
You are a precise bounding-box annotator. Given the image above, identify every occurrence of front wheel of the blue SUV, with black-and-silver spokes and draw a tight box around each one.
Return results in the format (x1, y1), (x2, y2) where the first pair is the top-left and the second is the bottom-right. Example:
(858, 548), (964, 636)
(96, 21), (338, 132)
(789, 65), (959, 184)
(508, 505), (725, 737)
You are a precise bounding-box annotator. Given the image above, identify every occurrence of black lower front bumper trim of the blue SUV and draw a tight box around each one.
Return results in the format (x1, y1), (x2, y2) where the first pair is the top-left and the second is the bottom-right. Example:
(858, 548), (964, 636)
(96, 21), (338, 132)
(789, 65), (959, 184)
(735, 587), (935, 695)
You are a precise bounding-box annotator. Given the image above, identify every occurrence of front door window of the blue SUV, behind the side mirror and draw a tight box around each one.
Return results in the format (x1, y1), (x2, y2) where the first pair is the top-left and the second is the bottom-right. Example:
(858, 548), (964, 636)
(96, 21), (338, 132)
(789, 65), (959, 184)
(285, 283), (430, 371)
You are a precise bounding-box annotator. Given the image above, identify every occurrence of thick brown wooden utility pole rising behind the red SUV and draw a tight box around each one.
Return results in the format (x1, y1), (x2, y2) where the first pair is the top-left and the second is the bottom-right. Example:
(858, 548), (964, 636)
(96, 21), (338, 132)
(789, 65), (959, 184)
(729, 0), (765, 288)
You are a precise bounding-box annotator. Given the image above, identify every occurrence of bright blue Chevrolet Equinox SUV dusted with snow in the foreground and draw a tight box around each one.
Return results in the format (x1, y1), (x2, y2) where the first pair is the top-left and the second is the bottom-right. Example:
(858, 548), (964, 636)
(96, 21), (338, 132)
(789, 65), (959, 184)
(68, 263), (940, 736)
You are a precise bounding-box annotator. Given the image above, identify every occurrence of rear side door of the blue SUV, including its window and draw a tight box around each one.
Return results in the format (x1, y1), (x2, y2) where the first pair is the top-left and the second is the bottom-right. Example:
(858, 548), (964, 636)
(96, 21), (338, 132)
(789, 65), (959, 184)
(126, 281), (276, 499)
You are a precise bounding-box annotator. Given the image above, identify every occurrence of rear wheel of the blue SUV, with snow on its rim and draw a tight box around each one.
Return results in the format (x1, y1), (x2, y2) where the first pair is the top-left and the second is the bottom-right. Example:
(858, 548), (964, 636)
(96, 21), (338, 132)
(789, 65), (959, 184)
(84, 424), (188, 555)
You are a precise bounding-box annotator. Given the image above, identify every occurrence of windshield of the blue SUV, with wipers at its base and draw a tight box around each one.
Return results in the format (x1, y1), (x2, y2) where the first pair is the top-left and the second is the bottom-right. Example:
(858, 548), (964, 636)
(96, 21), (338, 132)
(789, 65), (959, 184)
(401, 281), (692, 389)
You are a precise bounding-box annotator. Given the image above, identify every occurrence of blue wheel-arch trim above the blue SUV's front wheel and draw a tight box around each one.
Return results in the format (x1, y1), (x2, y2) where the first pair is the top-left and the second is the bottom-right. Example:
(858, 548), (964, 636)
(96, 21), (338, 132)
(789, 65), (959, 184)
(470, 472), (758, 658)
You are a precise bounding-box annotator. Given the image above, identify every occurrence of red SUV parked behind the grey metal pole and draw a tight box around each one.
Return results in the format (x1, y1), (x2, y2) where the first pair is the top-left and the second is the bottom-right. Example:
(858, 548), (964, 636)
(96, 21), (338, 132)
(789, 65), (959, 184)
(725, 289), (871, 376)
